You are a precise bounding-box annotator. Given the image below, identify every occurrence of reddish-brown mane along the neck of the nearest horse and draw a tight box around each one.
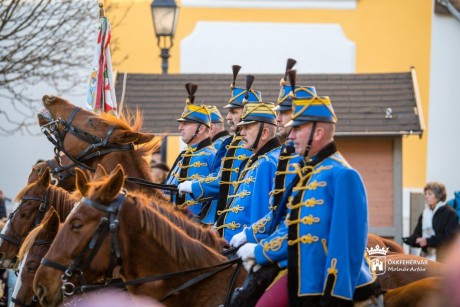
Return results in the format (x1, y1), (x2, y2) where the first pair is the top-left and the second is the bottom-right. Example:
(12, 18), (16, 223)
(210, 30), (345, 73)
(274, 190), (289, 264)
(132, 197), (227, 267)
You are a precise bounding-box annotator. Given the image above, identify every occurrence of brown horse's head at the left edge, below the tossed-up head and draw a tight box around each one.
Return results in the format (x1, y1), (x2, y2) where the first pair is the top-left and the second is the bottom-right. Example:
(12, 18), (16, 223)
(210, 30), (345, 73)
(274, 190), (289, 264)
(0, 169), (50, 268)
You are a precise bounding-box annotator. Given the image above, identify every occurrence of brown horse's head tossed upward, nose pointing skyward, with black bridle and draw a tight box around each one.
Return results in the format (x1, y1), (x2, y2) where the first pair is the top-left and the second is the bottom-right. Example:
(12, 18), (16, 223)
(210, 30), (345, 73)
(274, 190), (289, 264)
(38, 96), (161, 196)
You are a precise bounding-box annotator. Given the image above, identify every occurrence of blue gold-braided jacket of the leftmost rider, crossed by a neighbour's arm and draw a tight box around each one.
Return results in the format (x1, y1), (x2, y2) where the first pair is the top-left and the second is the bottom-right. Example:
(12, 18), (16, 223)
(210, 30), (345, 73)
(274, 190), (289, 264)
(165, 138), (216, 215)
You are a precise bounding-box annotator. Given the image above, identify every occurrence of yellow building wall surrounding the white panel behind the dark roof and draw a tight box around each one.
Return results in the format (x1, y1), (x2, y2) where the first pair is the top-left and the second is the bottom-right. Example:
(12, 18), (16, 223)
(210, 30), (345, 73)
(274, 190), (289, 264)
(106, 0), (432, 187)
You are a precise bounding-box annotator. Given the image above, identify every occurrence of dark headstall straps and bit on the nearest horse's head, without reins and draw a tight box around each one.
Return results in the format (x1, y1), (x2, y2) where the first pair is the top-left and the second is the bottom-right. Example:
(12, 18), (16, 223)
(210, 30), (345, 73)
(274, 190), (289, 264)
(41, 193), (125, 296)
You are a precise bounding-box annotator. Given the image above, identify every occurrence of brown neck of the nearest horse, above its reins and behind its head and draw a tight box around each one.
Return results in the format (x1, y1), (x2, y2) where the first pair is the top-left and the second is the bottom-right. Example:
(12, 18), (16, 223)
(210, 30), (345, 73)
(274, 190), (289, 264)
(120, 198), (226, 278)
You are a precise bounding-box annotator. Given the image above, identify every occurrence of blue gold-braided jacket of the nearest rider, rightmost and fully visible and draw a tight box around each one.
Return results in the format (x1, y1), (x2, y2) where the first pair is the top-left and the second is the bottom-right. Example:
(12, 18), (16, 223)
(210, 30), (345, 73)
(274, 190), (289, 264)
(254, 143), (375, 300)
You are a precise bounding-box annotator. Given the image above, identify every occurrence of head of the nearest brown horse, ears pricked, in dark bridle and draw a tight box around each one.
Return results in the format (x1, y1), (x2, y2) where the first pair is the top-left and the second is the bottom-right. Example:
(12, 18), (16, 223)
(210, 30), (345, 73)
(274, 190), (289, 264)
(34, 167), (124, 305)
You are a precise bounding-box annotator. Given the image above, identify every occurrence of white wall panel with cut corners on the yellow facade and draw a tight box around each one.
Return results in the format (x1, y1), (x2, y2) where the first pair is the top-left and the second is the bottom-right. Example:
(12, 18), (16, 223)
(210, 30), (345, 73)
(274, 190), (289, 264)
(180, 22), (356, 74)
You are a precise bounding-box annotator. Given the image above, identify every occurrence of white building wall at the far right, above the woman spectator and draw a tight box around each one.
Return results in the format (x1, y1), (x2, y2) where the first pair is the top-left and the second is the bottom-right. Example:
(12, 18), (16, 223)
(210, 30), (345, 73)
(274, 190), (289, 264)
(427, 14), (460, 199)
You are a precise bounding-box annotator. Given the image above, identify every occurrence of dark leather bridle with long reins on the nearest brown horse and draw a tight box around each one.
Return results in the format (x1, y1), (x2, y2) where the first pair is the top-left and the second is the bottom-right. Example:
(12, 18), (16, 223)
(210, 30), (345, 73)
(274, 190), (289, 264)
(41, 191), (242, 306)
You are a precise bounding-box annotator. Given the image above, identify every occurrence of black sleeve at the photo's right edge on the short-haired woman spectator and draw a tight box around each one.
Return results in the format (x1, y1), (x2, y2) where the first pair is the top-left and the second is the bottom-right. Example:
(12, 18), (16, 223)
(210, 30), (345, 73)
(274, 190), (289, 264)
(426, 206), (458, 247)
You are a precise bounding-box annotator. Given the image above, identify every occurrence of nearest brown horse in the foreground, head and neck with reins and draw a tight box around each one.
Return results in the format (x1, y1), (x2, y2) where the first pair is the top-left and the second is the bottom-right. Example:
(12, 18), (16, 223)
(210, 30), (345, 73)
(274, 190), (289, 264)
(34, 168), (246, 306)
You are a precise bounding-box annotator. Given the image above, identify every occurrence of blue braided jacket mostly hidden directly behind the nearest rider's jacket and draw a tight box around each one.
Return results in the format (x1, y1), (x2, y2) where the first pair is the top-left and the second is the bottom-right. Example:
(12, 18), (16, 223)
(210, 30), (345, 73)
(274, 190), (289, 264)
(245, 141), (303, 243)
